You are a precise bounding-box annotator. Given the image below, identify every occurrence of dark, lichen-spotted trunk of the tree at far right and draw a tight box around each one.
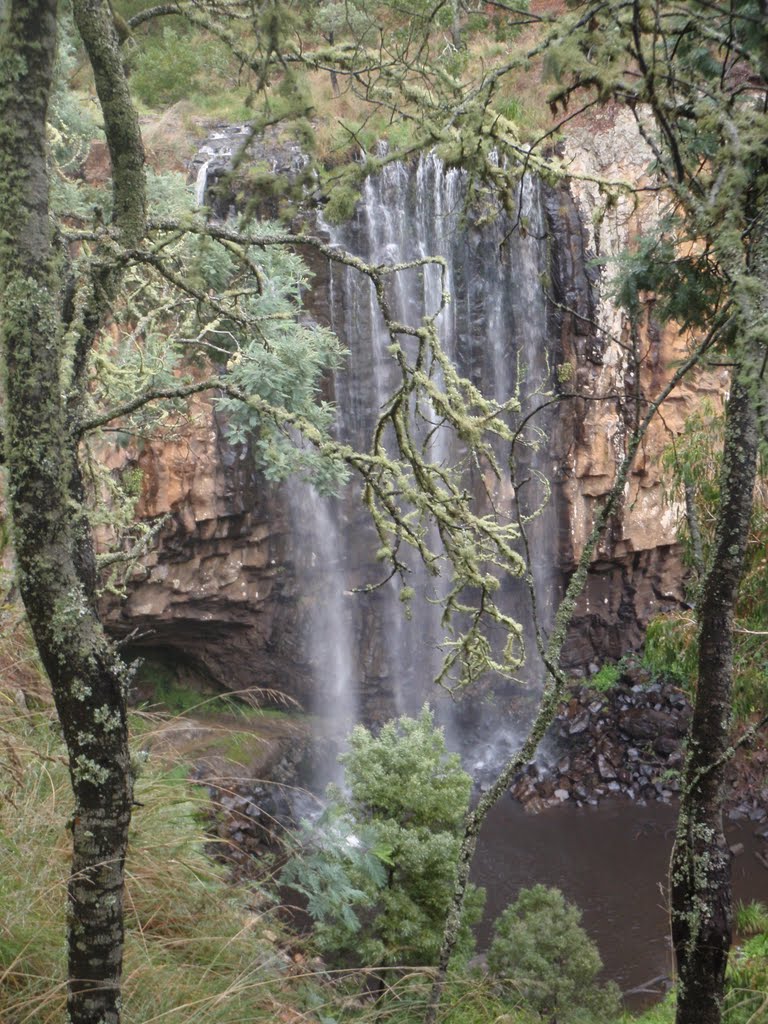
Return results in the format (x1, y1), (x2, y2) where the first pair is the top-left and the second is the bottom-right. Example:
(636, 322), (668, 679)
(671, 379), (758, 1024)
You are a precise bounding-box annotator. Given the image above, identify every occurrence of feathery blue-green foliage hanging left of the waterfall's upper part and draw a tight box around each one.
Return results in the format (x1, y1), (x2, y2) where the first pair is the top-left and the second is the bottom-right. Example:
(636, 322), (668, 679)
(83, 173), (347, 495)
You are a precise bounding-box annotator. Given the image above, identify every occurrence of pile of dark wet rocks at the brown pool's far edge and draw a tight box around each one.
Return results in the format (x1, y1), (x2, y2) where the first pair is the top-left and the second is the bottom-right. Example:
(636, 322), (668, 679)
(511, 677), (691, 812)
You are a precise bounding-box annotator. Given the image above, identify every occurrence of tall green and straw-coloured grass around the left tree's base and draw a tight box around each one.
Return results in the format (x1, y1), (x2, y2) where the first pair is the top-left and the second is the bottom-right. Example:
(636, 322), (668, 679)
(0, 671), (312, 1024)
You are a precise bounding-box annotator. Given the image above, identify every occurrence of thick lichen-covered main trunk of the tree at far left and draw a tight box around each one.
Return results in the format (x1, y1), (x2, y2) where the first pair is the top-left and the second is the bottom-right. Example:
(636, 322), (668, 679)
(0, 0), (145, 1024)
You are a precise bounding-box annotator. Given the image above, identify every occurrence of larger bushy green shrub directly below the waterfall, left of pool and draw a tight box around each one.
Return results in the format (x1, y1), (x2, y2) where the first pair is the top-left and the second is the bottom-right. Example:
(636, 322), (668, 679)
(284, 708), (482, 967)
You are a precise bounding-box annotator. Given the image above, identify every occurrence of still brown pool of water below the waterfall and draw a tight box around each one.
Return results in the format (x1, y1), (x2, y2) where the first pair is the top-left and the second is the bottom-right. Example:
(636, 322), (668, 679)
(473, 799), (768, 1001)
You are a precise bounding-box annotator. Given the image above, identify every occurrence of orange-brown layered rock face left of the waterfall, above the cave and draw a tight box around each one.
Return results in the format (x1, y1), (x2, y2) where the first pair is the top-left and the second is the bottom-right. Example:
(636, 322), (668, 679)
(103, 399), (313, 693)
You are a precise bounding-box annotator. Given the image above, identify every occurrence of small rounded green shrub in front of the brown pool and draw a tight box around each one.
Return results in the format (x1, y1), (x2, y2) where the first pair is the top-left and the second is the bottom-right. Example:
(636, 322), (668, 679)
(487, 886), (620, 1024)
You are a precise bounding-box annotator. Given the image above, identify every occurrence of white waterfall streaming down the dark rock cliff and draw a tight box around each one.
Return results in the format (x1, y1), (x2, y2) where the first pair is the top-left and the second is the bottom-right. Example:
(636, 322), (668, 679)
(289, 154), (556, 774)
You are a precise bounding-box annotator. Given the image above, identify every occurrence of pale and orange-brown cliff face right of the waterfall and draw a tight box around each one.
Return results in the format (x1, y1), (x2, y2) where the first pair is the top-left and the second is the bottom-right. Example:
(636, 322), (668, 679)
(563, 108), (727, 665)
